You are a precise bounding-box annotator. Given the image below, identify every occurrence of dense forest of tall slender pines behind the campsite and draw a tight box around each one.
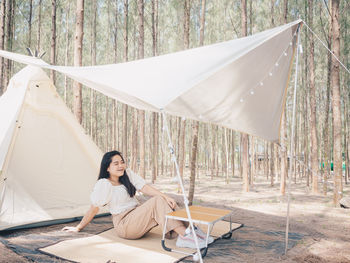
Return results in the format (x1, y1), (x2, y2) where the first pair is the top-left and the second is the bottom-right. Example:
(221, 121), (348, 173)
(0, 0), (350, 206)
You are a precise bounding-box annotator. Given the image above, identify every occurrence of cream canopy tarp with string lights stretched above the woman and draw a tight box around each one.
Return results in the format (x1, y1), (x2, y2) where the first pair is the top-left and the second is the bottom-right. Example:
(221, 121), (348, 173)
(0, 20), (302, 141)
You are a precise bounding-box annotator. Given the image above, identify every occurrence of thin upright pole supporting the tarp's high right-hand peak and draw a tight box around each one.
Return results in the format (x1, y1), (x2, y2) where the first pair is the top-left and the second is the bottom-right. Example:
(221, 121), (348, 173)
(284, 25), (300, 254)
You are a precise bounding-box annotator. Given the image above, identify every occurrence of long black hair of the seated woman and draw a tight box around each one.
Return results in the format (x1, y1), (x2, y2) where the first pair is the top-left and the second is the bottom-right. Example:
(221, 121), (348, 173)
(98, 151), (136, 197)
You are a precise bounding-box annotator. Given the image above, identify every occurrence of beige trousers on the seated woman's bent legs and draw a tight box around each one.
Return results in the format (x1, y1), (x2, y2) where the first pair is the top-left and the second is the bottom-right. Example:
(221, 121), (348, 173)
(113, 196), (184, 239)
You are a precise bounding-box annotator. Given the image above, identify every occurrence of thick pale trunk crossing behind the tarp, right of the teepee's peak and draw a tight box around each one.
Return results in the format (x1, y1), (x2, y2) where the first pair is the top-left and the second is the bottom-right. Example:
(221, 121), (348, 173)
(73, 0), (84, 124)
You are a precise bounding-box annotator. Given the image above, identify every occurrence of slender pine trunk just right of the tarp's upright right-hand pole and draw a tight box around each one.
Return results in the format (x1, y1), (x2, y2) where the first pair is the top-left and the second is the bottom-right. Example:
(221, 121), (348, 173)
(309, 0), (318, 193)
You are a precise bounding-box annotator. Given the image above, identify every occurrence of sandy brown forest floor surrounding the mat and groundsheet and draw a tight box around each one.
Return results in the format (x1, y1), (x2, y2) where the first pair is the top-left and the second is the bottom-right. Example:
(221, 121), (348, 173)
(0, 172), (350, 263)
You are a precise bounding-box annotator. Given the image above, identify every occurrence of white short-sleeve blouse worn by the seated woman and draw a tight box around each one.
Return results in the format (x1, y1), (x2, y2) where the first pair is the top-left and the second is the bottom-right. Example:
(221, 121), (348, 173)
(90, 168), (146, 214)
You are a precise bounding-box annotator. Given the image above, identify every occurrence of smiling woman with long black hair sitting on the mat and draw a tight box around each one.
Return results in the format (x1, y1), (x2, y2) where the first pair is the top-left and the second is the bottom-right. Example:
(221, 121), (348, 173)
(63, 151), (213, 248)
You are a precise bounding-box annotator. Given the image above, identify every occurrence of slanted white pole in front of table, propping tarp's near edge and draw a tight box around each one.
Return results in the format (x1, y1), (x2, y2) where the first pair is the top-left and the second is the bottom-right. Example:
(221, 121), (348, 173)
(161, 110), (203, 263)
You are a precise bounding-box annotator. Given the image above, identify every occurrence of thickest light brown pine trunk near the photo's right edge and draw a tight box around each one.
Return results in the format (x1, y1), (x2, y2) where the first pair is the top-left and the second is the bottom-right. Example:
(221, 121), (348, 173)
(331, 0), (343, 206)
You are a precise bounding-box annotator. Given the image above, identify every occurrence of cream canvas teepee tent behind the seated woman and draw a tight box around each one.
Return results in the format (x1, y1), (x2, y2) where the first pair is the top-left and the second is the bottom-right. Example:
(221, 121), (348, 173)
(0, 66), (106, 230)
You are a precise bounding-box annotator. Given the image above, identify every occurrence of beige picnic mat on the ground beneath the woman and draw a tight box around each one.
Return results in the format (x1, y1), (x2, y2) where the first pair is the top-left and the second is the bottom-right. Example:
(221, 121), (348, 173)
(39, 221), (242, 263)
